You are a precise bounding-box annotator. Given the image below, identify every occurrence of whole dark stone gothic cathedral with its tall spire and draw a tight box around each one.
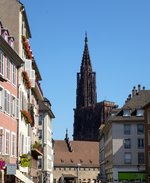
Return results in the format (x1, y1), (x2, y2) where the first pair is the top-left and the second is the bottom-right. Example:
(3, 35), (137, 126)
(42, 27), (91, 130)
(73, 35), (115, 141)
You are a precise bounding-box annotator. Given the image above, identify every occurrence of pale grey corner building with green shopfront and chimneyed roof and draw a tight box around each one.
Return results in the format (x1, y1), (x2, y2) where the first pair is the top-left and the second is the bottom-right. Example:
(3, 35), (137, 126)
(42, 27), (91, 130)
(100, 86), (150, 182)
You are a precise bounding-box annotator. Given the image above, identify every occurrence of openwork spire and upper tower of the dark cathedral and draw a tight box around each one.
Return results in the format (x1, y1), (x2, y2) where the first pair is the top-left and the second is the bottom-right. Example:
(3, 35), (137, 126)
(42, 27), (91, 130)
(76, 34), (97, 108)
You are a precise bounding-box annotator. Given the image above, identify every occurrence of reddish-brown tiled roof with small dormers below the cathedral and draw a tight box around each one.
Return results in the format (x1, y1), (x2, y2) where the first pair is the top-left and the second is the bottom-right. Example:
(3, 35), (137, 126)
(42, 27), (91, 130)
(54, 140), (99, 167)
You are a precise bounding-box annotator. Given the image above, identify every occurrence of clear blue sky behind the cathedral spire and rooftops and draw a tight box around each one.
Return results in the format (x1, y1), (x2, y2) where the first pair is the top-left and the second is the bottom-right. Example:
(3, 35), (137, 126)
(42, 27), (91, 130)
(22, 0), (150, 139)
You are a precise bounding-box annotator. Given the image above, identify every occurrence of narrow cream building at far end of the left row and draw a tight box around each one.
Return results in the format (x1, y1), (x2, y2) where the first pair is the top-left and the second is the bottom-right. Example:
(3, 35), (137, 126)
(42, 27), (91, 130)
(39, 98), (55, 183)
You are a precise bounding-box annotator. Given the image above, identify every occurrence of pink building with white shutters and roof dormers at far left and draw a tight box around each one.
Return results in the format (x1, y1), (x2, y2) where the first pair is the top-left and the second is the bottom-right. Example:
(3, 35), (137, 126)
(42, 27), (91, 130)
(0, 23), (23, 181)
